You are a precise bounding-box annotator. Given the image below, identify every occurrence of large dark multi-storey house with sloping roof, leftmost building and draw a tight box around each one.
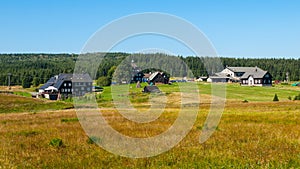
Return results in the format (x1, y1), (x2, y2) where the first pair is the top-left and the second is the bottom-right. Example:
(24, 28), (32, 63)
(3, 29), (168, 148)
(39, 74), (93, 98)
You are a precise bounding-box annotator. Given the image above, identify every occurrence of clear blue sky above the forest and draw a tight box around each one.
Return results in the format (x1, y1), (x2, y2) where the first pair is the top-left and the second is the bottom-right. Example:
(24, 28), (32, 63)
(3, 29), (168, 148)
(0, 0), (300, 58)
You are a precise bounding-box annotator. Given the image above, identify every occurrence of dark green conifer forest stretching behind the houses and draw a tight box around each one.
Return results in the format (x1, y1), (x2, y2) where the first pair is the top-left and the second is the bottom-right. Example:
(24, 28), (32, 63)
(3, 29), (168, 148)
(0, 53), (300, 88)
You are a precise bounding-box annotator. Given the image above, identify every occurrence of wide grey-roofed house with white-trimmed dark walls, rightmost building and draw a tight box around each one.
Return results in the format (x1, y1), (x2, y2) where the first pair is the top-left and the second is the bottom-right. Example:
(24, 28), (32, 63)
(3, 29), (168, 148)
(207, 66), (272, 86)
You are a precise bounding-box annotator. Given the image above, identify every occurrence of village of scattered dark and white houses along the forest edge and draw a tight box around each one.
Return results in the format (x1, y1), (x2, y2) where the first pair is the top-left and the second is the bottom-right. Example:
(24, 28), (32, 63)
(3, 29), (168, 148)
(33, 61), (300, 100)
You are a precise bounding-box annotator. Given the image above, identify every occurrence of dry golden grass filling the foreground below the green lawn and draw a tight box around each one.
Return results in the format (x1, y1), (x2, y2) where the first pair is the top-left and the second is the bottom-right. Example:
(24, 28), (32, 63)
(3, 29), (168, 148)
(0, 101), (300, 168)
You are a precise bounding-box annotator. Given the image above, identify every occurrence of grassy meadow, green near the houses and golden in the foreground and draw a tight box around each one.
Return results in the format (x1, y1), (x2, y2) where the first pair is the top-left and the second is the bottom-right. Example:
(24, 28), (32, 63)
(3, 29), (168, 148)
(0, 83), (300, 168)
